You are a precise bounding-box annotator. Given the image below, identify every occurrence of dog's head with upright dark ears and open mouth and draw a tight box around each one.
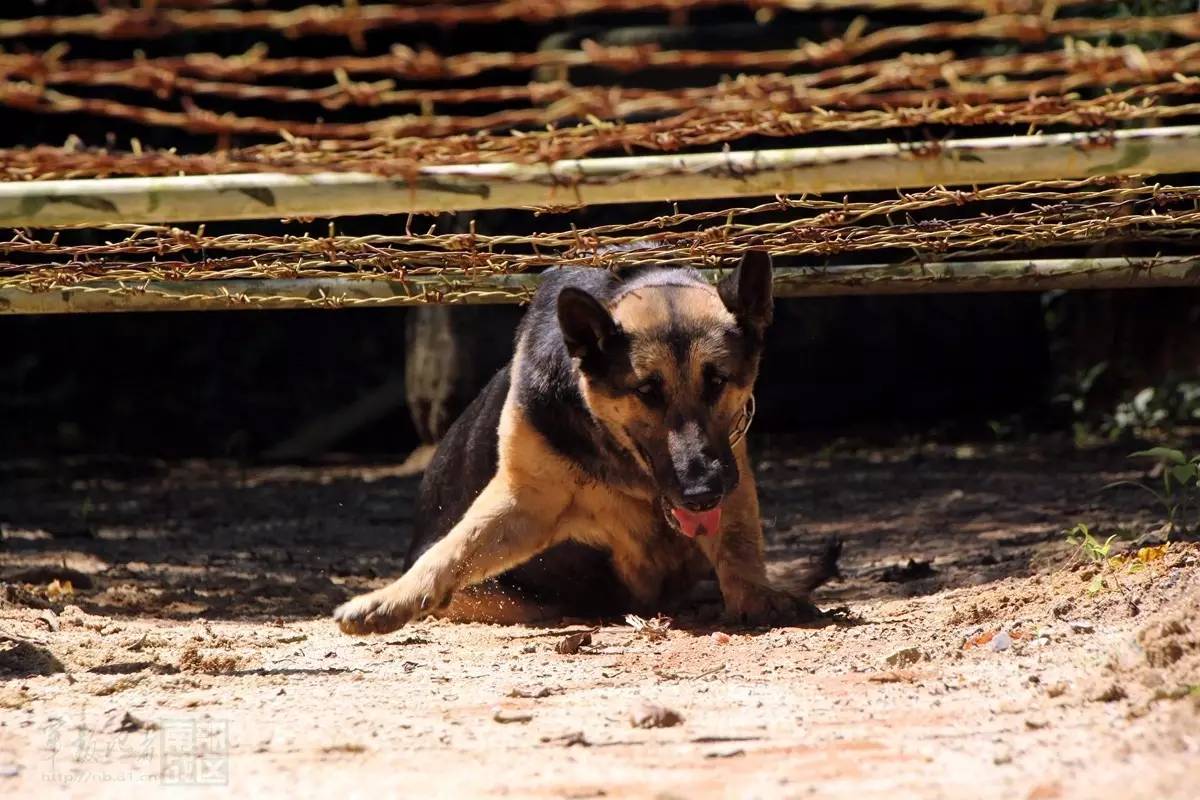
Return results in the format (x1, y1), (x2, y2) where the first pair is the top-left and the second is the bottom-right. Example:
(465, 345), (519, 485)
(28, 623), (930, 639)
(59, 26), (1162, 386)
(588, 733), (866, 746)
(558, 252), (772, 536)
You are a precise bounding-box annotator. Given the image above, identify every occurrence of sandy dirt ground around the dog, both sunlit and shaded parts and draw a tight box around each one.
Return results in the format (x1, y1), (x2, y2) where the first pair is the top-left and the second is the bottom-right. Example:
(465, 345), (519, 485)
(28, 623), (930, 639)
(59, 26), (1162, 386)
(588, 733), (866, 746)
(0, 439), (1200, 800)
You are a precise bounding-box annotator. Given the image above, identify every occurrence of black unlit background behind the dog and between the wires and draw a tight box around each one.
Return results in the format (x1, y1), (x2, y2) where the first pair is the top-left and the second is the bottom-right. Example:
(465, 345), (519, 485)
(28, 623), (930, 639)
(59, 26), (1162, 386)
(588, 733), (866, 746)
(0, 0), (1200, 461)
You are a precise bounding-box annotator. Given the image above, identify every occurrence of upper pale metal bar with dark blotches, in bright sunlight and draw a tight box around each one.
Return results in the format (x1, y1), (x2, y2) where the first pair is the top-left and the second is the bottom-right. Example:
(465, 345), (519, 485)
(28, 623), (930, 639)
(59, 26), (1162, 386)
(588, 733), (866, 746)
(0, 125), (1200, 227)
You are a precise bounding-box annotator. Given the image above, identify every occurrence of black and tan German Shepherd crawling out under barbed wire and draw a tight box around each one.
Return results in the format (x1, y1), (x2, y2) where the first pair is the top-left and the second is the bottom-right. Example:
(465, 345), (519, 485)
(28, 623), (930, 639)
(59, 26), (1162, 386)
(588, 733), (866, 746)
(334, 252), (838, 634)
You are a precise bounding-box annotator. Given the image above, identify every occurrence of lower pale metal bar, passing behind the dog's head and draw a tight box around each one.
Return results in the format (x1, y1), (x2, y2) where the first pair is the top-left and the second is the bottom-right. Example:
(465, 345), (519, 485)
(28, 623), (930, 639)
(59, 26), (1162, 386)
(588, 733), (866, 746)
(0, 255), (1200, 314)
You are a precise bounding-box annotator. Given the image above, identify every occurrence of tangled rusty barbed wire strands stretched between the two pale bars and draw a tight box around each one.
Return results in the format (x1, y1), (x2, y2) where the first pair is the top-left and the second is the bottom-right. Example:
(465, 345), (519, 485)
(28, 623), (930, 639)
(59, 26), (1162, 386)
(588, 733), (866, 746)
(0, 187), (1200, 290)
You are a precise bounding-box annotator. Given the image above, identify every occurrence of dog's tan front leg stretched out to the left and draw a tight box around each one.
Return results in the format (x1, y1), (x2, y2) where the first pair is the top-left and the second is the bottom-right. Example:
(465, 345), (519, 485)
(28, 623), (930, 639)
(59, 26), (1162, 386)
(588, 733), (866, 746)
(334, 476), (569, 636)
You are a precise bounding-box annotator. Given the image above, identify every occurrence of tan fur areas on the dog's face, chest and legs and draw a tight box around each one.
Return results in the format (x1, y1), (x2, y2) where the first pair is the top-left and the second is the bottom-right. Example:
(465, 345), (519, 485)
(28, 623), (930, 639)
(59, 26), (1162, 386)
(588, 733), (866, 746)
(337, 260), (830, 634)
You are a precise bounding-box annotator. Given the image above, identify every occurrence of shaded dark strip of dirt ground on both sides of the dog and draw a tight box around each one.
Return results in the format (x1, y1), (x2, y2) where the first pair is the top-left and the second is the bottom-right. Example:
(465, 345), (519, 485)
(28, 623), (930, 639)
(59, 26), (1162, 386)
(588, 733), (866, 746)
(0, 440), (1154, 619)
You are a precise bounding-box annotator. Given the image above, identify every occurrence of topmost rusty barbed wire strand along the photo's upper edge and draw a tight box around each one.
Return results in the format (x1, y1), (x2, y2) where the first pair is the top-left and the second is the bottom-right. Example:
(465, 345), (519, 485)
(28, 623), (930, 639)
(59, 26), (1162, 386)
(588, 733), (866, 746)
(0, 0), (1113, 46)
